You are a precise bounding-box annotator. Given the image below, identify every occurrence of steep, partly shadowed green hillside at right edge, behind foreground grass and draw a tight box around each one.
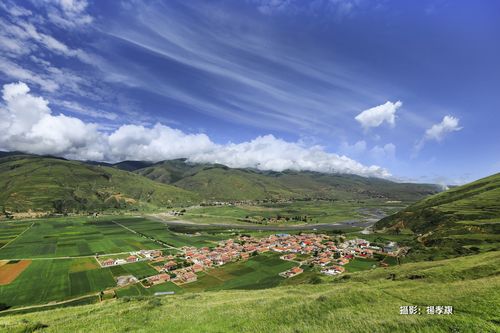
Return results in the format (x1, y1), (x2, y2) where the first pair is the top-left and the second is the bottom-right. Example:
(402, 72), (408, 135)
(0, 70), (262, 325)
(376, 173), (500, 251)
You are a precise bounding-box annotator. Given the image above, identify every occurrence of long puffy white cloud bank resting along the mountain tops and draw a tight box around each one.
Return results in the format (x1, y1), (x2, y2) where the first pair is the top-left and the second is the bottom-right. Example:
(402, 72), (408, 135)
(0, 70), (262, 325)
(0, 82), (390, 177)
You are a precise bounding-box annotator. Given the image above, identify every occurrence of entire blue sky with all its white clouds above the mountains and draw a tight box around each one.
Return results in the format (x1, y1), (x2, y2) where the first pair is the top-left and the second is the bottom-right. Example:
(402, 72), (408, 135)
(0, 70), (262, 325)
(0, 0), (500, 184)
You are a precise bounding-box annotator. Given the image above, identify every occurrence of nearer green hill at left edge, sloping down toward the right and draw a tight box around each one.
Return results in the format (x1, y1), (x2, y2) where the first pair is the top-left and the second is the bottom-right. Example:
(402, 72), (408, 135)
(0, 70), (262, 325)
(0, 155), (197, 213)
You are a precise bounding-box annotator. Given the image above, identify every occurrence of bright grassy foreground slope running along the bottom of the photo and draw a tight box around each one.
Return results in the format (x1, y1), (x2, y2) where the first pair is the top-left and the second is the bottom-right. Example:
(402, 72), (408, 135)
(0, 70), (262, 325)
(0, 252), (500, 333)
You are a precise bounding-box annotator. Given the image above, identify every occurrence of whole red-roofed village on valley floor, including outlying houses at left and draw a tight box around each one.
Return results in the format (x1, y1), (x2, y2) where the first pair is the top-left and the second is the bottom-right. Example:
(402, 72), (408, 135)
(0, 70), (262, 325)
(96, 233), (404, 288)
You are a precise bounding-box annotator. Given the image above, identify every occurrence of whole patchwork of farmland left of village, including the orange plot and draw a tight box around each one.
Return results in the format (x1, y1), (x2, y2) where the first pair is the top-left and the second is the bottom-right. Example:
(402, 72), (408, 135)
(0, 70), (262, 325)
(0, 217), (247, 307)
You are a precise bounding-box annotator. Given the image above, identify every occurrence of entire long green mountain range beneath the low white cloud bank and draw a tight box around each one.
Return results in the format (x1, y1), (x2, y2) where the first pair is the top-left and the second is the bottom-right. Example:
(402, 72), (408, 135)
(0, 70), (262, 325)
(0, 152), (439, 212)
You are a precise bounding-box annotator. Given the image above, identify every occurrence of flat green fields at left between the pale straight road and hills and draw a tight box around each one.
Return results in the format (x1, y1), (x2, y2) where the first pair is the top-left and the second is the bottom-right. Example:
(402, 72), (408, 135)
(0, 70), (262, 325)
(0, 217), (161, 259)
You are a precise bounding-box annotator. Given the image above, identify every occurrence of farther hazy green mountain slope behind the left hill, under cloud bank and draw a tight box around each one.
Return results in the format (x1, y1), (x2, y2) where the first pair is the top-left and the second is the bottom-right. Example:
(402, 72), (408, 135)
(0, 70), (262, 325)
(135, 159), (438, 201)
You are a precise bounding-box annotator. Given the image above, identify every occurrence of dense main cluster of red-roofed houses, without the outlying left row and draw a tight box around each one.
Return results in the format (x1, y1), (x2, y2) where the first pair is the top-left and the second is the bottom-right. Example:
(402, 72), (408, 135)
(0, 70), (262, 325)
(157, 234), (397, 283)
